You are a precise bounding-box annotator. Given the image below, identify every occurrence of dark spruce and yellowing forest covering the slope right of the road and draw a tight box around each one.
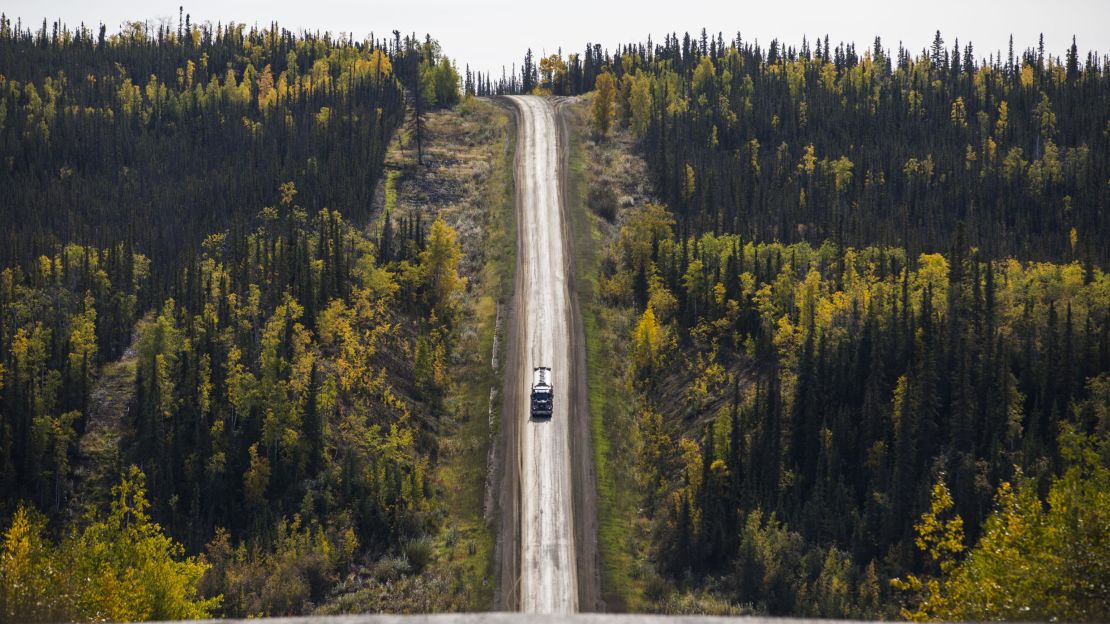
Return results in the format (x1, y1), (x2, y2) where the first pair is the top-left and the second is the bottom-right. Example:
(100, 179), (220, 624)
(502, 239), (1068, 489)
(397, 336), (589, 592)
(495, 31), (1110, 621)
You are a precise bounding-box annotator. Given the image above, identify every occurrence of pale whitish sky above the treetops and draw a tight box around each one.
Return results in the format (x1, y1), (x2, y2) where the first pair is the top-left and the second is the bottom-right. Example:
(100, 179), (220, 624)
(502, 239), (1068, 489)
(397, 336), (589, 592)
(8, 0), (1110, 73)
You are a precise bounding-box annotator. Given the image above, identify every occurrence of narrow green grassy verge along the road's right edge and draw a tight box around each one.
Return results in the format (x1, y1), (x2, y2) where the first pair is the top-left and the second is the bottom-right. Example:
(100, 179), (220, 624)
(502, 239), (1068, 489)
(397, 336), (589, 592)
(567, 97), (645, 612)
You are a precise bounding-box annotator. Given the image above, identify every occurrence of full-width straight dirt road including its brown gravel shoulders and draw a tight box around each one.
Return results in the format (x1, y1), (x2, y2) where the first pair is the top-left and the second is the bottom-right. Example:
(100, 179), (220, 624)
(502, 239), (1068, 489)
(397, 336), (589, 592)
(498, 97), (596, 613)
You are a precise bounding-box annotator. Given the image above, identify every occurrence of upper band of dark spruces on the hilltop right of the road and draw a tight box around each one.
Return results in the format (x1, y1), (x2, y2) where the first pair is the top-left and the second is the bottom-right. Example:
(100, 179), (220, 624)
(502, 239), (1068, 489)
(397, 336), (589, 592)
(494, 31), (1110, 266)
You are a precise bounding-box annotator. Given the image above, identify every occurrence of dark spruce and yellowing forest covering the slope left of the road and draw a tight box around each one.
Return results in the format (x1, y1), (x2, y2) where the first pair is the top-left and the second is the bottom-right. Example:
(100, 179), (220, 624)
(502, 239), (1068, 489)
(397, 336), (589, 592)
(0, 16), (472, 622)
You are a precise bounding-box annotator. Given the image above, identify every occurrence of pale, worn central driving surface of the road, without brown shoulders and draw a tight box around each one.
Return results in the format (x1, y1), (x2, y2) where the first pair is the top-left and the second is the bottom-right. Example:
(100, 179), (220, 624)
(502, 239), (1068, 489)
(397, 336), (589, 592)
(506, 95), (578, 614)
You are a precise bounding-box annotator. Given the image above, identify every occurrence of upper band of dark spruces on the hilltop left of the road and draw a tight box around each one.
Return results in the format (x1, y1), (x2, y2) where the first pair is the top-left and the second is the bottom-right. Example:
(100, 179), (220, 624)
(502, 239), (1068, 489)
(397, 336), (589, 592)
(0, 16), (458, 304)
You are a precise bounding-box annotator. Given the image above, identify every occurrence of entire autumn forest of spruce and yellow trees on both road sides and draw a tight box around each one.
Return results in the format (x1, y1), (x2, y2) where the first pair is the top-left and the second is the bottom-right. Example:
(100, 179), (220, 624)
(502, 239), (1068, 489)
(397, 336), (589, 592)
(0, 10), (1110, 622)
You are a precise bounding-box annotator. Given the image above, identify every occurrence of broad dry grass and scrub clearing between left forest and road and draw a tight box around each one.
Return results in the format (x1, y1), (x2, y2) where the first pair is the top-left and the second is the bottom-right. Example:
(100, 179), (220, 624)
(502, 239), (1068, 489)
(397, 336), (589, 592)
(317, 98), (516, 614)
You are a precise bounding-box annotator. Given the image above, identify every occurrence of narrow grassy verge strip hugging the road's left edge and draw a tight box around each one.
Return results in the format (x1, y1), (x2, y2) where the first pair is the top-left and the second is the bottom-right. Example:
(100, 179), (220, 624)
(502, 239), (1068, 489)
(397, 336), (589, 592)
(435, 100), (516, 611)
